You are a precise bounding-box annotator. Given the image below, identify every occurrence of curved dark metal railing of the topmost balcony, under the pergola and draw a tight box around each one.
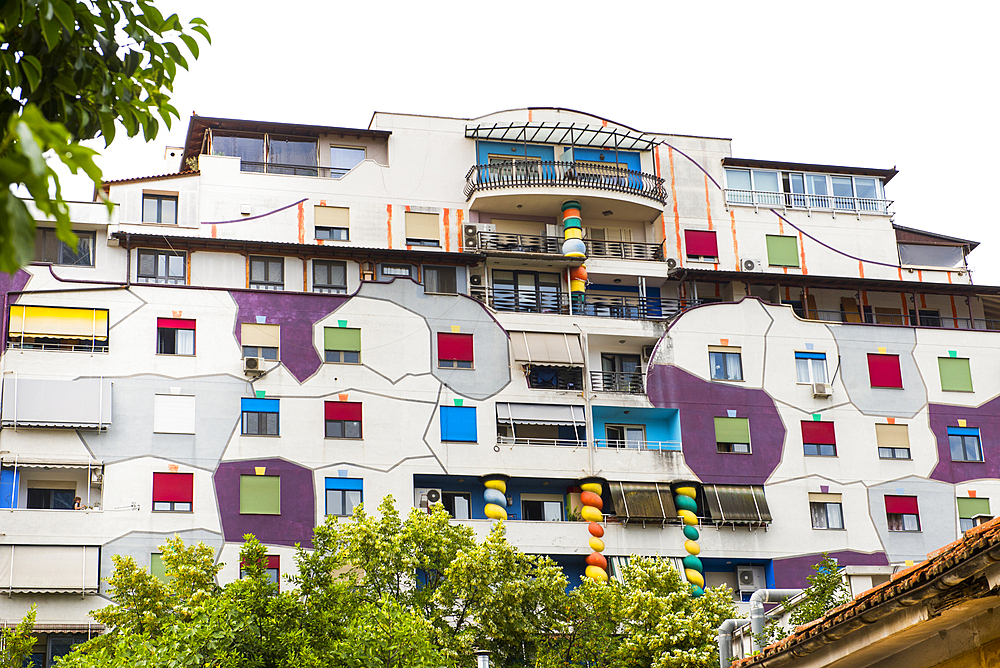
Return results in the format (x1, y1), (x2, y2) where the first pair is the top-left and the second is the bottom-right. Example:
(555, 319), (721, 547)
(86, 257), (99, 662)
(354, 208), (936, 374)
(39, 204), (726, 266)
(465, 160), (667, 204)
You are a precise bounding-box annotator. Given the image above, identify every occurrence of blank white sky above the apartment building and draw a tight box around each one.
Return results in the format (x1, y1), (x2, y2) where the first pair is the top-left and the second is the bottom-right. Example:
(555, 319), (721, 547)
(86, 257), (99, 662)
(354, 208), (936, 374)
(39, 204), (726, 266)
(64, 0), (1000, 284)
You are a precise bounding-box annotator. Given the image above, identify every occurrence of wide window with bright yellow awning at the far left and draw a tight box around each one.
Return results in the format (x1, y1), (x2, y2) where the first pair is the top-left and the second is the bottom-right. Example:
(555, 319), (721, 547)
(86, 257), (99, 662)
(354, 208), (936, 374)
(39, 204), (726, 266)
(7, 305), (108, 353)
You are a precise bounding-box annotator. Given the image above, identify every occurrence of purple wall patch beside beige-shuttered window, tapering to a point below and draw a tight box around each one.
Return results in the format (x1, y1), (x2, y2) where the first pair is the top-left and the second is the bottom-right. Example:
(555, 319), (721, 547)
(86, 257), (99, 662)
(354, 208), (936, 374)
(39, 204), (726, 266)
(229, 290), (350, 383)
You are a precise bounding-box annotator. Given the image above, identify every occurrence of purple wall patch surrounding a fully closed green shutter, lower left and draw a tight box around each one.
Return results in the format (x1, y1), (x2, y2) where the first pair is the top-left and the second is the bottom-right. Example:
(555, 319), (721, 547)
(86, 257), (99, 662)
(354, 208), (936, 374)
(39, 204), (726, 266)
(212, 459), (316, 547)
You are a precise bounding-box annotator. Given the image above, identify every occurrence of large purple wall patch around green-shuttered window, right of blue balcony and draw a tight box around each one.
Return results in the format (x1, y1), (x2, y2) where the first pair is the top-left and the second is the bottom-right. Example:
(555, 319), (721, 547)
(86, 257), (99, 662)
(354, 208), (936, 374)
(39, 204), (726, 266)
(646, 364), (785, 485)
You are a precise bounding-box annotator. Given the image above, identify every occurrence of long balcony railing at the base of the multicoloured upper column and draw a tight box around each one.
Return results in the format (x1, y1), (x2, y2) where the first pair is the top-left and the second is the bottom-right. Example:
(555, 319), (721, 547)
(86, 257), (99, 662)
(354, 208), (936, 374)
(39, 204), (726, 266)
(472, 287), (701, 320)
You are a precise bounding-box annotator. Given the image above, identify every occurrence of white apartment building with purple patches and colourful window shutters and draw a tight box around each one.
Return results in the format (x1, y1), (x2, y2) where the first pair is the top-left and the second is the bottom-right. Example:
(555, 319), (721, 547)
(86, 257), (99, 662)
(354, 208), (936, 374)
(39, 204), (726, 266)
(0, 109), (1000, 665)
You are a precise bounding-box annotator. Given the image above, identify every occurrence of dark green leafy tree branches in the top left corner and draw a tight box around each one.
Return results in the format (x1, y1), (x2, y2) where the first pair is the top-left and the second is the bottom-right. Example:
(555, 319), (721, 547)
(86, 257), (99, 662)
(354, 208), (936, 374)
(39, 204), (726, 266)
(0, 0), (210, 273)
